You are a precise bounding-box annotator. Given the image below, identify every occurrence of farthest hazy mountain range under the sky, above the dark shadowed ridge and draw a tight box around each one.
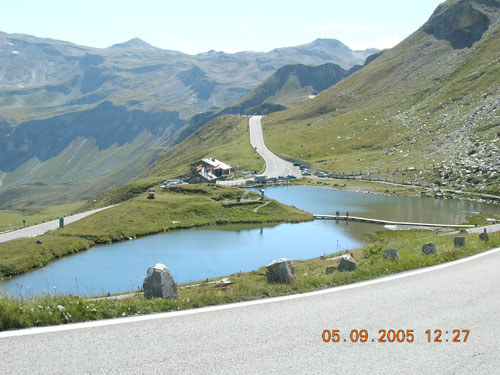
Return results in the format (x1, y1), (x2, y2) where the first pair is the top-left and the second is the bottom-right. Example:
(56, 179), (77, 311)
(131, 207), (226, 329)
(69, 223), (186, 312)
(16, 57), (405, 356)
(0, 33), (373, 125)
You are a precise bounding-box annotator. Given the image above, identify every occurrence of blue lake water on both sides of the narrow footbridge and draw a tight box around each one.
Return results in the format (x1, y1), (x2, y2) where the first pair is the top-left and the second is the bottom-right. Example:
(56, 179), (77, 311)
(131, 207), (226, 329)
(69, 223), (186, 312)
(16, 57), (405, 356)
(0, 186), (500, 297)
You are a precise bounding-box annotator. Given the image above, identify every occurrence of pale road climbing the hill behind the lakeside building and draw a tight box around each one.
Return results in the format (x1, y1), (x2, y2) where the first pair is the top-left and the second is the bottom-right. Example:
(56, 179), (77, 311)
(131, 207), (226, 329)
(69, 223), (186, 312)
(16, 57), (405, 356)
(249, 116), (301, 177)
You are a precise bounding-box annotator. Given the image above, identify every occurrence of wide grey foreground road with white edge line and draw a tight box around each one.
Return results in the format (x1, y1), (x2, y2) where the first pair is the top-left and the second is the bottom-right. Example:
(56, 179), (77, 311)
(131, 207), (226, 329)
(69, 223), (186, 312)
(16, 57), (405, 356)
(0, 249), (500, 374)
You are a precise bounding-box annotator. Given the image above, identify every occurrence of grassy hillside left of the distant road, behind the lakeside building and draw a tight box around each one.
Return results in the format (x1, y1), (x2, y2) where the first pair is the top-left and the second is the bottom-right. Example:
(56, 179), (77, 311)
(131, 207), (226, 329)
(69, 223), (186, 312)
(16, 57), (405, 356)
(139, 116), (264, 178)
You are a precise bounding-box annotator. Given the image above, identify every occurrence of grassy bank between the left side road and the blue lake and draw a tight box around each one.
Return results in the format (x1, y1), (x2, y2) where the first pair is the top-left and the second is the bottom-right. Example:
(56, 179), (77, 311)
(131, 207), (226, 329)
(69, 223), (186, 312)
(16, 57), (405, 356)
(0, 184), (312, 277)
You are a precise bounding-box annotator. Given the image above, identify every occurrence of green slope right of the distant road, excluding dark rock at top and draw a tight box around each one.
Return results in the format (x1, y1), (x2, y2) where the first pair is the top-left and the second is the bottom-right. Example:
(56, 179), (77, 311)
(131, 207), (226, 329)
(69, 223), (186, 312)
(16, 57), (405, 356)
(263, 11), (500, 192)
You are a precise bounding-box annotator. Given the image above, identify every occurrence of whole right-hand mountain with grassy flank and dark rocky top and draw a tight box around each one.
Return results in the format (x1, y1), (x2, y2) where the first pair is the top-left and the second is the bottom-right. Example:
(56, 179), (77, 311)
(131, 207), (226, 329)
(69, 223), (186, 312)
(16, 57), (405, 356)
(258, 0), (500, 192)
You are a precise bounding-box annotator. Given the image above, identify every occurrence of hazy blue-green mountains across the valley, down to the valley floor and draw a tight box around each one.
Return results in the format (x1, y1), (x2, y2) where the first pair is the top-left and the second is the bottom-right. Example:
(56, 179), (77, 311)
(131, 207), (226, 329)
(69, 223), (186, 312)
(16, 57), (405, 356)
(0, 32), (372, 206)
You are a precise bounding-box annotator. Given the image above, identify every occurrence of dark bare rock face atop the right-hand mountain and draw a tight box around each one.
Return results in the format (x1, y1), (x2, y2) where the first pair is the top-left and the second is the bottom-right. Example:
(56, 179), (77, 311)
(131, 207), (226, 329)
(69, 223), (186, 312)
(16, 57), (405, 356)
(424, 0), (492, 49)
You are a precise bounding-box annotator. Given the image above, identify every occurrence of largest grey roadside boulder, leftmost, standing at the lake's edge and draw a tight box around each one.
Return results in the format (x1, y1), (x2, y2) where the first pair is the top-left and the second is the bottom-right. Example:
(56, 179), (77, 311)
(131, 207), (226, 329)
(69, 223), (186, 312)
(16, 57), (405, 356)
(142, 263), (179, 299)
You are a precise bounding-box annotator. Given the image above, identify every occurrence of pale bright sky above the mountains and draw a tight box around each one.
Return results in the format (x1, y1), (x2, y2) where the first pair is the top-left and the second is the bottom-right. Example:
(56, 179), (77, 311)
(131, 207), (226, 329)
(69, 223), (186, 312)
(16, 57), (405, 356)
(0, 0), (442, 54)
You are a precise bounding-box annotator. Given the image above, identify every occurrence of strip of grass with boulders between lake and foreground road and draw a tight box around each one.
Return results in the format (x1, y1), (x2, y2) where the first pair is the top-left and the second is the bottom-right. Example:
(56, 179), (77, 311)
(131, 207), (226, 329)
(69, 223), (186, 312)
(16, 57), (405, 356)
(0, 231), (500, 330)
